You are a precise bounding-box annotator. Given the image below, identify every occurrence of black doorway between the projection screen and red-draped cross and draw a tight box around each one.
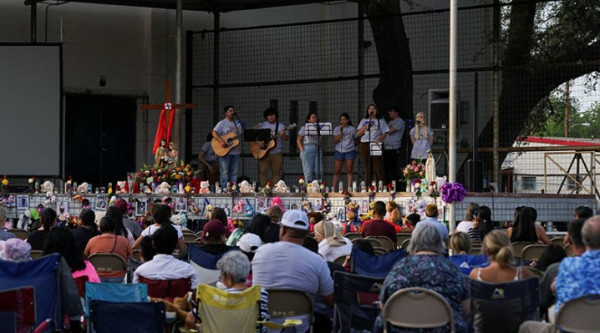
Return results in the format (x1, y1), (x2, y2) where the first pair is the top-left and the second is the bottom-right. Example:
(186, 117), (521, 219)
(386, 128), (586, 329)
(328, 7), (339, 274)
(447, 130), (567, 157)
(65, 95), (137, 188)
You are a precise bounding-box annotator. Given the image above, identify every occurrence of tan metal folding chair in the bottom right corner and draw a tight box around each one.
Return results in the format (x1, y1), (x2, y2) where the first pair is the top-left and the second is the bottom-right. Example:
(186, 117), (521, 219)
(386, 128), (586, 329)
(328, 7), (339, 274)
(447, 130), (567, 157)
(554, 295), (600, 333)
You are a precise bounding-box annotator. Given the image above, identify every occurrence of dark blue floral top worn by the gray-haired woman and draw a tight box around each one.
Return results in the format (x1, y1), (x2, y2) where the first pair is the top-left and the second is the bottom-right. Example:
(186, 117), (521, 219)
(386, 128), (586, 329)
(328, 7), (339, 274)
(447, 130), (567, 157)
(374, 255), (471, 333)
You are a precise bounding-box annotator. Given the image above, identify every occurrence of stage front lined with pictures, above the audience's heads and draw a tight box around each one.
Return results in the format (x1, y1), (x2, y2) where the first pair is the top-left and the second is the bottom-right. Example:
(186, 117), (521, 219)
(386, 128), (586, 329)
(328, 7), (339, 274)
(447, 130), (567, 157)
(6, 192), (597, 227)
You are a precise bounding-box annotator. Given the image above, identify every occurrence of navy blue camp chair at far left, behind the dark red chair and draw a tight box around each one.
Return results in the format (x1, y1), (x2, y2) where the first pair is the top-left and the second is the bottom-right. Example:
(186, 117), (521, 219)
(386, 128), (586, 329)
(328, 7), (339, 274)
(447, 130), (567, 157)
(0, 253), (64, 327)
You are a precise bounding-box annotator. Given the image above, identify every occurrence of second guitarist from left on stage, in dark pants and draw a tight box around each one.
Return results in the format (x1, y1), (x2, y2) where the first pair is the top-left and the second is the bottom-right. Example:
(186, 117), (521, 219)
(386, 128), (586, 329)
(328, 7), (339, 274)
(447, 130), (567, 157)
(251, 108), (290, 187)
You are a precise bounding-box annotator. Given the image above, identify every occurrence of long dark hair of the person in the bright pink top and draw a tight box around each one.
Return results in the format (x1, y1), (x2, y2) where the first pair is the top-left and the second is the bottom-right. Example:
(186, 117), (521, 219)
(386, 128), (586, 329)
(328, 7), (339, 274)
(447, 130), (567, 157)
(44, 227), (85, 272)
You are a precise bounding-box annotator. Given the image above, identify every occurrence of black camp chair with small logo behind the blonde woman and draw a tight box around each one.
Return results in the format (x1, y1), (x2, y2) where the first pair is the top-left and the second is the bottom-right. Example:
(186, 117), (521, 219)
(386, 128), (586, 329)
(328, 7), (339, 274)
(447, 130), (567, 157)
(470, 277), (540, 333)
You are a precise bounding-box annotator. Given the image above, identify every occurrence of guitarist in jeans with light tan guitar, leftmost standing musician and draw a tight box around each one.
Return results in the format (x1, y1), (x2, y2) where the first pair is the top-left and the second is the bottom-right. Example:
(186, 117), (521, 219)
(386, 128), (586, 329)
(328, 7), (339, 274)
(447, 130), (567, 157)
(211, 106), (243, 188)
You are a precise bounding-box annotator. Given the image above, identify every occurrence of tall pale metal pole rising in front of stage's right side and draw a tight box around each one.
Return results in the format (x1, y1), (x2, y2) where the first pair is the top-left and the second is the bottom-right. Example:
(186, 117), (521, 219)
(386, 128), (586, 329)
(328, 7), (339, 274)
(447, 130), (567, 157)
(448, 0), (458, 233)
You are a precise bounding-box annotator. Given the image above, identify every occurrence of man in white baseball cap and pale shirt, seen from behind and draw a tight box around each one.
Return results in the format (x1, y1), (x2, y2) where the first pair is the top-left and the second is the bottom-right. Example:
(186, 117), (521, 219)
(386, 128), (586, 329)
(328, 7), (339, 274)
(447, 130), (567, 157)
(252, 210), (333, 332)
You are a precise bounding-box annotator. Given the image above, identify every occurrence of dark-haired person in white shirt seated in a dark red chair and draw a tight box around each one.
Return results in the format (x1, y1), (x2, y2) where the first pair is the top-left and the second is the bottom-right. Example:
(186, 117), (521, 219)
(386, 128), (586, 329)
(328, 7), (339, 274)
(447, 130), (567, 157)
(133, 224), (198, 289)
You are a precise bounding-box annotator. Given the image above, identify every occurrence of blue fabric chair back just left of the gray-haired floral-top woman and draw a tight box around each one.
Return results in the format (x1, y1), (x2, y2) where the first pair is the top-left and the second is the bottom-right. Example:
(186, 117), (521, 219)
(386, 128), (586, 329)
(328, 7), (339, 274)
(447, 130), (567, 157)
(350, 247), (406, 279)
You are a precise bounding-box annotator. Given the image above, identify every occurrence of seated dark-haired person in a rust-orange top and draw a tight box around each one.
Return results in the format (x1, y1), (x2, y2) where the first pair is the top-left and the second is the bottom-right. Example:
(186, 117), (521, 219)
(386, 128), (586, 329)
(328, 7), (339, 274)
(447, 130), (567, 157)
(83, 216), (132, 283)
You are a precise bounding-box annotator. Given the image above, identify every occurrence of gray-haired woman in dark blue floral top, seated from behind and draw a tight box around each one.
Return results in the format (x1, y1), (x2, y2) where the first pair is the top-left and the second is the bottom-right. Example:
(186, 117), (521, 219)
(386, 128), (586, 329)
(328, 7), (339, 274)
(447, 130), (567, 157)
(375, 220), (471, 332)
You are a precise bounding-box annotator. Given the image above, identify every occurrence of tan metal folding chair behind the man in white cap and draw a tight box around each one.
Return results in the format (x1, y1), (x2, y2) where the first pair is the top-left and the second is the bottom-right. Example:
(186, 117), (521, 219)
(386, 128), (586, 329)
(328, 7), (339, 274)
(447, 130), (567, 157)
(267, 288), (314, 332)
